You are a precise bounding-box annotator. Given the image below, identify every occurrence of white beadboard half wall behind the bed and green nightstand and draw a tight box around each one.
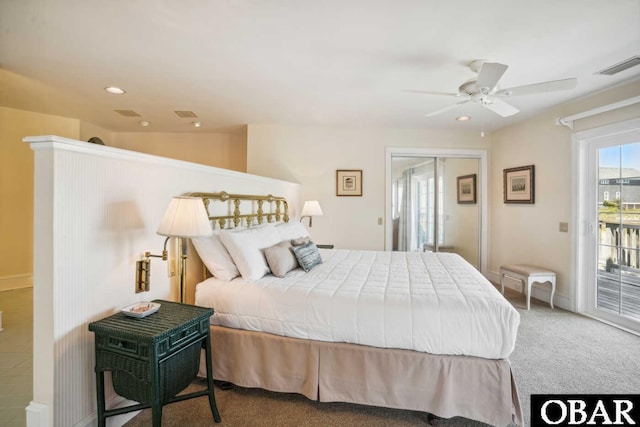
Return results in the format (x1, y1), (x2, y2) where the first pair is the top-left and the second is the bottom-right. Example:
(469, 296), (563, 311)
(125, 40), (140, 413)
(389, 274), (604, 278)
(25, 136), (299, 427)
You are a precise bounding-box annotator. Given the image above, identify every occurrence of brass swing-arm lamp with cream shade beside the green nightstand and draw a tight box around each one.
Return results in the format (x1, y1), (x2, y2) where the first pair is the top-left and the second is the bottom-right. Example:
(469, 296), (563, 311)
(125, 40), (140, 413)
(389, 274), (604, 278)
(136, 196), (212, 303)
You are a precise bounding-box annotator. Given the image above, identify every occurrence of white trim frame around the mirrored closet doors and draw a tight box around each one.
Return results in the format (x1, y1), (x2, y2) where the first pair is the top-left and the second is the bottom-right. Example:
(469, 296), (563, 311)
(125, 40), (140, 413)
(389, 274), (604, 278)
(384, 147), (489, 276)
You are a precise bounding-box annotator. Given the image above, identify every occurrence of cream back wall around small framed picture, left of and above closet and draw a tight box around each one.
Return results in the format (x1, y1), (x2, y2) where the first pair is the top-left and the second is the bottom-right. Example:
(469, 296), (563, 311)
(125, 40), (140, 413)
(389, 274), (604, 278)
(247, 125), (489, 250)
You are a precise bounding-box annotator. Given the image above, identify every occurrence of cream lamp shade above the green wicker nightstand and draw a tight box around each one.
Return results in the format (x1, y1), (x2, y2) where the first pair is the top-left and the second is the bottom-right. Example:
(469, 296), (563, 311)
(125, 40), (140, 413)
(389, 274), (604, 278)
(158, 196), (211, 237)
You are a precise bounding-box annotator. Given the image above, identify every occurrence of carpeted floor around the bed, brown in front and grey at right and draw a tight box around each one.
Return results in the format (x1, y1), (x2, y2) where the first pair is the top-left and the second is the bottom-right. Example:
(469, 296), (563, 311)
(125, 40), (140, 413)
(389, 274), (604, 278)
(125, 290), (640, 427)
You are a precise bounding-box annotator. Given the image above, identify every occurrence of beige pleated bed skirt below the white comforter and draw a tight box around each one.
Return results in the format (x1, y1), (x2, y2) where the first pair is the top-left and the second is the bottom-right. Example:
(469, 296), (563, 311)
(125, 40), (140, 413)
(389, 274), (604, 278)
(200, 325), (522, 426)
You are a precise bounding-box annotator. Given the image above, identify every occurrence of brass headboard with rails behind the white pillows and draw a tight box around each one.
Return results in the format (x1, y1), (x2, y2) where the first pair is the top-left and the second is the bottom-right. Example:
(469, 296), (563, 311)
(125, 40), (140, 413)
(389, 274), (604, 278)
(185, 191), (289, 229)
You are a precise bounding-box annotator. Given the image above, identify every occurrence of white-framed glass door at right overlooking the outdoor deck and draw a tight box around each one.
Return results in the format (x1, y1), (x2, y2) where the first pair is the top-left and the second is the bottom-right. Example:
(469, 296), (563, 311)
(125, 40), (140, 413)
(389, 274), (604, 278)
(574, 119), (640, 332)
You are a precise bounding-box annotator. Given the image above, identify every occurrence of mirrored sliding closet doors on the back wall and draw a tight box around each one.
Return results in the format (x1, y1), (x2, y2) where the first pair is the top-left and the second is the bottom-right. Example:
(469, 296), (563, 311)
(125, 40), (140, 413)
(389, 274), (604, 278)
(389, 155), (481, 269)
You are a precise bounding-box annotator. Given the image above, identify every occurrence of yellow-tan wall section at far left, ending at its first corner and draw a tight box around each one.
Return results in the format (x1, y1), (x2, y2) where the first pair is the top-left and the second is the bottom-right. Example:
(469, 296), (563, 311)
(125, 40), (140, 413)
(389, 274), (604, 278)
(0, 107), (79, 290)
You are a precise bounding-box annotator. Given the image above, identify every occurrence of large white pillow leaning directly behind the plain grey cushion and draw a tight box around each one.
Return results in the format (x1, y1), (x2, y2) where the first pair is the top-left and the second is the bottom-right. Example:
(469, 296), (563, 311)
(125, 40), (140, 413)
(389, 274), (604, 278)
(220, 225), (281, 282)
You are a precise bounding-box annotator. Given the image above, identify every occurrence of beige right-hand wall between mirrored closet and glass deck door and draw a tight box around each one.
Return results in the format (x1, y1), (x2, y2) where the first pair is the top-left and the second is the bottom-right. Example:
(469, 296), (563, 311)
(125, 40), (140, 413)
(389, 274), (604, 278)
(489, 82), (640, 302)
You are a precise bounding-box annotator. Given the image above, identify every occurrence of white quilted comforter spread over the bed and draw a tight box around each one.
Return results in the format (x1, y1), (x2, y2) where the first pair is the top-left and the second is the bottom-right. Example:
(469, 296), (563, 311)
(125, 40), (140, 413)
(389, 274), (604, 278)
(196, 249), (520, 359)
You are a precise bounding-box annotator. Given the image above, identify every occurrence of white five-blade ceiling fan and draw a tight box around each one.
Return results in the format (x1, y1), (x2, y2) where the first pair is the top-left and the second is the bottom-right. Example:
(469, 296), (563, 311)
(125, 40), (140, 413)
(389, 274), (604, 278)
(411, 60), (578, 117)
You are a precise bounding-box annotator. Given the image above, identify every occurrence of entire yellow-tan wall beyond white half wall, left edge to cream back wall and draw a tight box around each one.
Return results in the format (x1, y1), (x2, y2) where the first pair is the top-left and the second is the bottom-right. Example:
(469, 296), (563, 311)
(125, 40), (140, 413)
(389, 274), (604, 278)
(0, 107), (247, 290)
